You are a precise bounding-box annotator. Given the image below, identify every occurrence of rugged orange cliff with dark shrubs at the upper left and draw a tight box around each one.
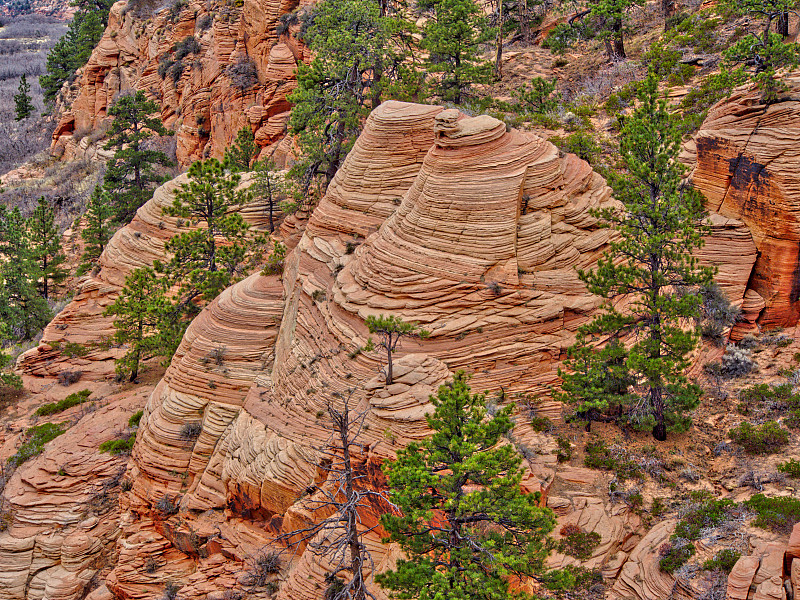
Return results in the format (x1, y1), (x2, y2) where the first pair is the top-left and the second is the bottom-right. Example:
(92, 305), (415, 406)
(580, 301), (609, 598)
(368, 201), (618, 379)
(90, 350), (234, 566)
(53, 0), (307, 165)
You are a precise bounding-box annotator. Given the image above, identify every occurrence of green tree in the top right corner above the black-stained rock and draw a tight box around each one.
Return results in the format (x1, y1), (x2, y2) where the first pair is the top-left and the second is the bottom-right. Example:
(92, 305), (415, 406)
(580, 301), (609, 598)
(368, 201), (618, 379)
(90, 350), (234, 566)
(723, 0), (798, 104)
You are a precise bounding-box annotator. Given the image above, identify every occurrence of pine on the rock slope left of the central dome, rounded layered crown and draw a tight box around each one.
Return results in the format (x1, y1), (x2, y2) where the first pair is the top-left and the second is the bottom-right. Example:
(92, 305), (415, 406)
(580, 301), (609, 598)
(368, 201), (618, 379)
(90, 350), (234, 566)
(164, 158), (261, 309)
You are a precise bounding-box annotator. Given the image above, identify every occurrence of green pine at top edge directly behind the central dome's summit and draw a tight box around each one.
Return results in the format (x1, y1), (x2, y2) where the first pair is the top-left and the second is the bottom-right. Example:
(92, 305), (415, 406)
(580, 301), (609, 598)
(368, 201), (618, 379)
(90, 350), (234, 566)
(419, 0), (495, 104)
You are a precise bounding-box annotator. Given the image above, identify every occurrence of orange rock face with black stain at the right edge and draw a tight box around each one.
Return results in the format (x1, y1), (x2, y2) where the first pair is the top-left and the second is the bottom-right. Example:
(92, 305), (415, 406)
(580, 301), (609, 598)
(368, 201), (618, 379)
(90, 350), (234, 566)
(688, 75), (800, 326)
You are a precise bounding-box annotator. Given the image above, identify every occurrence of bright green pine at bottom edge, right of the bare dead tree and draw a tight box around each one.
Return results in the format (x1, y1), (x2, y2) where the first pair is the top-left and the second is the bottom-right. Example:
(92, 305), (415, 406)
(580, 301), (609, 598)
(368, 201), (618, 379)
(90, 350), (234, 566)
(376, 371), (555, 600)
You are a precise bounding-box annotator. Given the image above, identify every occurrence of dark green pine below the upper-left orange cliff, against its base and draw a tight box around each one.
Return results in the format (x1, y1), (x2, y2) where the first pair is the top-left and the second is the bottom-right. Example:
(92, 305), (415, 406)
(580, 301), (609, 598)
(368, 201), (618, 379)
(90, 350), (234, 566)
(103, 90), (172, 223)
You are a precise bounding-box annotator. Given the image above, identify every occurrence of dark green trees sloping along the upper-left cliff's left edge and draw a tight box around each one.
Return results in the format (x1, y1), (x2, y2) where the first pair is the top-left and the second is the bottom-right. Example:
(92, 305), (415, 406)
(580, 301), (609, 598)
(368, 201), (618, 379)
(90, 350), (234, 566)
(39, 0), (113, 103)
